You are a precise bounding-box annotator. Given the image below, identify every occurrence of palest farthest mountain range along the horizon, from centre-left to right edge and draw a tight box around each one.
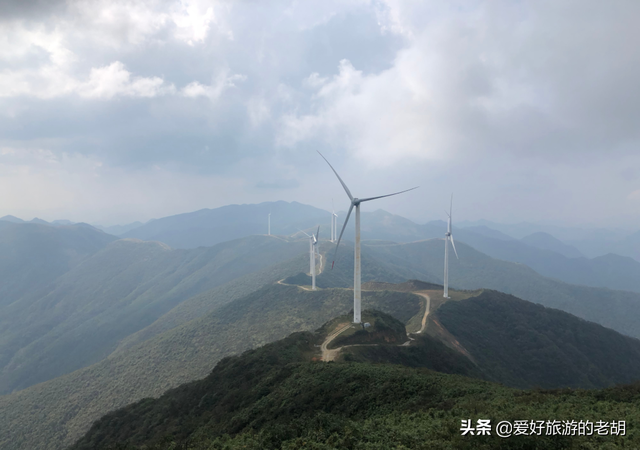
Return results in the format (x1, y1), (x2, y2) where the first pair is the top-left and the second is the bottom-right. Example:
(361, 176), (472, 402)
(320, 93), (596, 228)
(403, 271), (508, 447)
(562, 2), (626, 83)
(123, 202), (640, 292)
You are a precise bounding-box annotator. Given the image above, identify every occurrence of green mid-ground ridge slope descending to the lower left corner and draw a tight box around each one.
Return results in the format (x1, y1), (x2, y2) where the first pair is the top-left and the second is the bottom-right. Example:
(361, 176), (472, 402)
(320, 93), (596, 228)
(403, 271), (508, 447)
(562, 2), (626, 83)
(0, 284), (420, 450)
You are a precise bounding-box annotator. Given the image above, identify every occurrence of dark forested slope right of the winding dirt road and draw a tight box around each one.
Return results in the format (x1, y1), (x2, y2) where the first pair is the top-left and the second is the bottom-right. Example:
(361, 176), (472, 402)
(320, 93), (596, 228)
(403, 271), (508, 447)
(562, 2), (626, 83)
(433, 290), (640, 388)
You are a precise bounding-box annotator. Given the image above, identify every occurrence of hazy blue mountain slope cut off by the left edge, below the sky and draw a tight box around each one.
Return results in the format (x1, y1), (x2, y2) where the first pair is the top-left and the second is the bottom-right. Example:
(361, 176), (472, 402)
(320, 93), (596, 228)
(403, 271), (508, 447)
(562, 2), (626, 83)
(0, 222), (117, 310)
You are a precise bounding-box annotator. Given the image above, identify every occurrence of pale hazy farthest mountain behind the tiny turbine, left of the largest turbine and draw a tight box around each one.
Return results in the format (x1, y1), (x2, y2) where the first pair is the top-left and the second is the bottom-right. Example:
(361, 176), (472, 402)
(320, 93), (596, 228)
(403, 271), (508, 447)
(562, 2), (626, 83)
(122, 201), (330, 249)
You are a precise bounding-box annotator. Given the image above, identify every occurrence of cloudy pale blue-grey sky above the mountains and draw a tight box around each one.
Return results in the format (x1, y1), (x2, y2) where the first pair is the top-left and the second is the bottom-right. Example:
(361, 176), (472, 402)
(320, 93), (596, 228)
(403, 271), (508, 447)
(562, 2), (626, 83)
(0, 0), (640, 225)
